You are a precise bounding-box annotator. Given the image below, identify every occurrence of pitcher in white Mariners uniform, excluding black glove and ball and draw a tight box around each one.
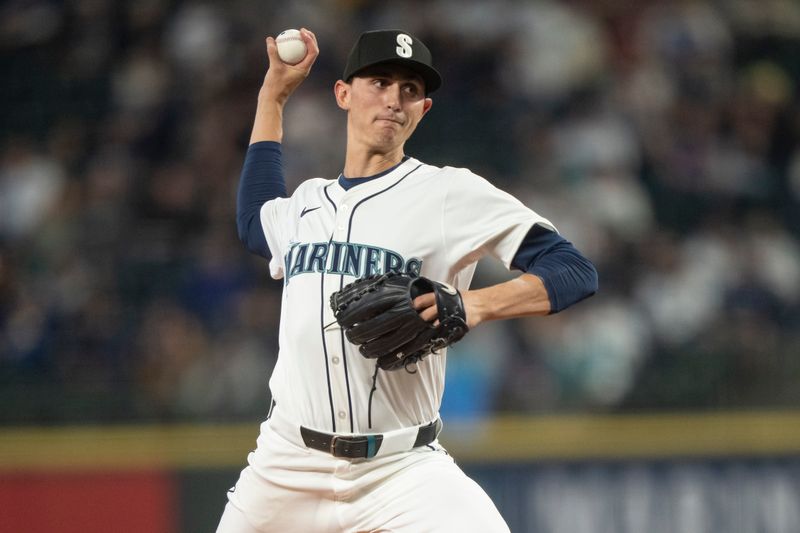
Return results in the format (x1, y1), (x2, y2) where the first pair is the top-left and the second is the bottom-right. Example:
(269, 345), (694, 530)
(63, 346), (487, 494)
(218, 29), (597, 533)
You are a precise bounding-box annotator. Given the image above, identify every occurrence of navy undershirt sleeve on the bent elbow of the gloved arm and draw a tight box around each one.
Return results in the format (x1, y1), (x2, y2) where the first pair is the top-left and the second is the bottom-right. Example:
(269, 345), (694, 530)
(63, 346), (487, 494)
(511, 225), (598, 314)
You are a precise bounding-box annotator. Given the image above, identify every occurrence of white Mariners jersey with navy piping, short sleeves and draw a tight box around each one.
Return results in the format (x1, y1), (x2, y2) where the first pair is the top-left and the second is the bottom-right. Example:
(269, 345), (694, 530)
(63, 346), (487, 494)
(261, 158), (555, 433)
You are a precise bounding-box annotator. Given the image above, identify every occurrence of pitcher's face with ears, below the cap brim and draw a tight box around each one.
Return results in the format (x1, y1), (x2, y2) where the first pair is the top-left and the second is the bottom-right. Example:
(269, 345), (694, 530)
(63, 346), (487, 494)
(337, 65), (433, 151)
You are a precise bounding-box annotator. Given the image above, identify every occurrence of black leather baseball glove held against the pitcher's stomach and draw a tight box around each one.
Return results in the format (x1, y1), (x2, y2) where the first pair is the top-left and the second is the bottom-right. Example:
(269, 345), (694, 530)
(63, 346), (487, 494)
(331, 272), (469, 370)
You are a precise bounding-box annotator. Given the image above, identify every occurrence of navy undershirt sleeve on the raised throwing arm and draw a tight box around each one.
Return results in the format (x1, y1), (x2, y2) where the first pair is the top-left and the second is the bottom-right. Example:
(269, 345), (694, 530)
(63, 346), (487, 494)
(236, 141), (287, 259)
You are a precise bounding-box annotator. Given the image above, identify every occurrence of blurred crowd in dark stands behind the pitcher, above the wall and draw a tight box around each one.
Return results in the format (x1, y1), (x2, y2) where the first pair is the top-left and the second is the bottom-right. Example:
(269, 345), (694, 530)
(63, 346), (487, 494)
(0, 0), (800, 424)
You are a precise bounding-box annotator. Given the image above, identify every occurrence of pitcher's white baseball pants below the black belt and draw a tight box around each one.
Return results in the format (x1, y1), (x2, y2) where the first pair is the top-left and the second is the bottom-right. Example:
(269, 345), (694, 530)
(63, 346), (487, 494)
(217, 414), (509, 533)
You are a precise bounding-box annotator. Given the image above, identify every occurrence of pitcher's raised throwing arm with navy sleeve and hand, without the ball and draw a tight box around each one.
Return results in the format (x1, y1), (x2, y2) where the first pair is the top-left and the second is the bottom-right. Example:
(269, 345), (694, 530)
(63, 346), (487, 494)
(236, 28), (319, 259)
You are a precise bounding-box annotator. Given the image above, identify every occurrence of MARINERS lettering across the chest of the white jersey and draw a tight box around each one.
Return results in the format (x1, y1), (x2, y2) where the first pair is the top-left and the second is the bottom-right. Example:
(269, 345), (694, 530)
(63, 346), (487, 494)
(283, 240), (422, 284)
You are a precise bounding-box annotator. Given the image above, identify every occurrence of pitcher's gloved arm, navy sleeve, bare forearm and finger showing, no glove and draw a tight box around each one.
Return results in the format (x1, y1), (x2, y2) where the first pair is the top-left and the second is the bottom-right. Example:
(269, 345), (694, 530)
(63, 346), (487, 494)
(414, 225), (598, 328)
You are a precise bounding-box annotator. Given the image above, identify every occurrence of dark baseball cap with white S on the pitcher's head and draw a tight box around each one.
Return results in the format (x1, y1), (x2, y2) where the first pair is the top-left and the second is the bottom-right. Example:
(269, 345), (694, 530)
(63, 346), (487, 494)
(342, 30), (442, 94)
